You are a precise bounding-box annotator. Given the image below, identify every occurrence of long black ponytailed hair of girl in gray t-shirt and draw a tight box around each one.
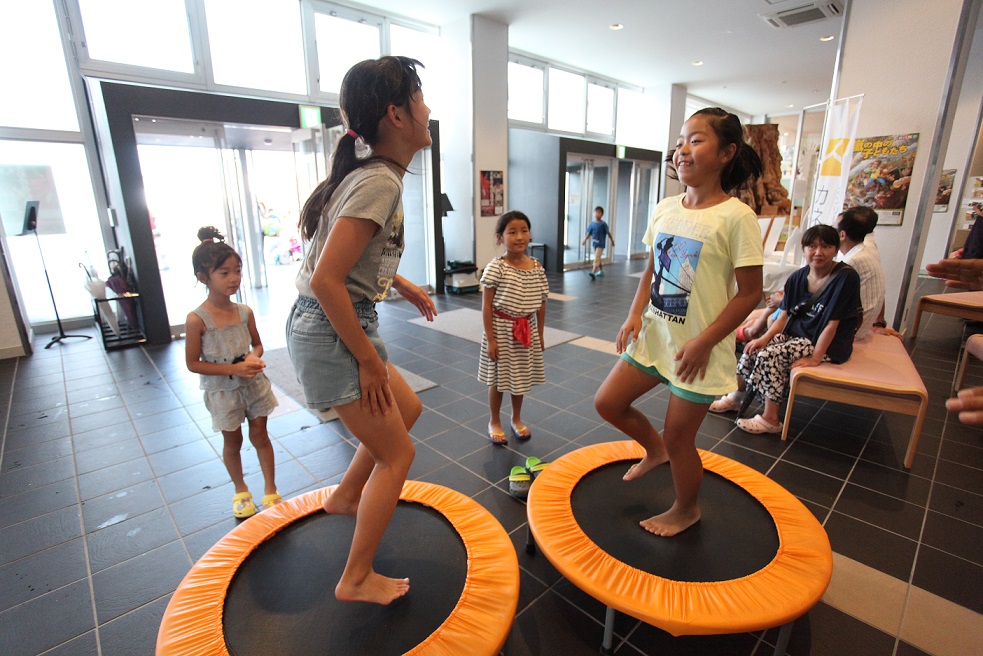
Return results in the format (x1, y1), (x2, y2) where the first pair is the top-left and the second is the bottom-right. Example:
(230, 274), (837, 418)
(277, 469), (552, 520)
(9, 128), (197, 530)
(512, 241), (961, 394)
(298, 56), (423, 240)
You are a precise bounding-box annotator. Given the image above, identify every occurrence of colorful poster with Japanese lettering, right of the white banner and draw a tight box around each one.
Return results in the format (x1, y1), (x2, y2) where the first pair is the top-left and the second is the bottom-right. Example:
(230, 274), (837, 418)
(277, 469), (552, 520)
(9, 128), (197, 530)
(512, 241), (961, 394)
(841, 132), (918, 225)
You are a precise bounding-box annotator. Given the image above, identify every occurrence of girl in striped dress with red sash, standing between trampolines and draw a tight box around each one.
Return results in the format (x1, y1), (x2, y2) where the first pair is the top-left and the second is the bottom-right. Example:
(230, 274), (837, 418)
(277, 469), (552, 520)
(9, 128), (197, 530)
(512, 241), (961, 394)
(478, 211), (549, 444)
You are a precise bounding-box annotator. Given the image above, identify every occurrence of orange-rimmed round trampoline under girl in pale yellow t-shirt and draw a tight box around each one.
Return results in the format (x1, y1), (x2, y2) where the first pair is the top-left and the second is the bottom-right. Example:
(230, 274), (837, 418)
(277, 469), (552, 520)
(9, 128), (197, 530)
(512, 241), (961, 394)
(528, 441), (833, 654)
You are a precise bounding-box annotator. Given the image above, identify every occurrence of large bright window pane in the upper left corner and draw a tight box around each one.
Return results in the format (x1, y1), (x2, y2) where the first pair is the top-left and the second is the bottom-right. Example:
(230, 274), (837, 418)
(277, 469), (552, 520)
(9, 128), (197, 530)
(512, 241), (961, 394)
(0, 2), (79, 132)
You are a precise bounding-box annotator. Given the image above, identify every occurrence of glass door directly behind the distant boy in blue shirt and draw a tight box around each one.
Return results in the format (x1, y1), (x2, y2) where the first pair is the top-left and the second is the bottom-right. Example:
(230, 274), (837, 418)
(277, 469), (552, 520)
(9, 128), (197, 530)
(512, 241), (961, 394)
(563, 155), (617, 271)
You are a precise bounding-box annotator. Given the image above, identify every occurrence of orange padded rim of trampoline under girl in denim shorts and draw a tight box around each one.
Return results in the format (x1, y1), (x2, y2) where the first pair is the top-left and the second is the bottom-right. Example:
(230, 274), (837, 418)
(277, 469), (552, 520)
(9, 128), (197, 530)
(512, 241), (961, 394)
(156, 481), (519, 656)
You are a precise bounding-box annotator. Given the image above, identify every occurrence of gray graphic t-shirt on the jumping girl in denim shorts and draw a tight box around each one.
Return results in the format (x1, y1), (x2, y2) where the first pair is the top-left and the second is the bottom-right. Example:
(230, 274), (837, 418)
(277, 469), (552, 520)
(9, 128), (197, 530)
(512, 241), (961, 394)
(297, 162), (404, 303)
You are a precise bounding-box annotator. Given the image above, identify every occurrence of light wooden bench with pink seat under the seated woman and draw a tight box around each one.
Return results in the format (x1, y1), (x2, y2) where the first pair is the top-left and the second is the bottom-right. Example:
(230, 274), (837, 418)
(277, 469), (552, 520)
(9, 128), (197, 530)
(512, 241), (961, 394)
(782, 333), (928, 469)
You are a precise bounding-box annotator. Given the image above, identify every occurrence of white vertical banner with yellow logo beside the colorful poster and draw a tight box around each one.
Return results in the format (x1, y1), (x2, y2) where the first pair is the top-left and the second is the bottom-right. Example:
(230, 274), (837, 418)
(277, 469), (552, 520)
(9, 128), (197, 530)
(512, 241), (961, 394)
(806, 95), (863, 226)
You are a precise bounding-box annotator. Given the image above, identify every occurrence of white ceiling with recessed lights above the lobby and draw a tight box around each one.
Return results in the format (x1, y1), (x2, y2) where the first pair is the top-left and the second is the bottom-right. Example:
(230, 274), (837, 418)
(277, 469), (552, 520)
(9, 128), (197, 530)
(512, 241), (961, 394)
(350, 0), (842, 115)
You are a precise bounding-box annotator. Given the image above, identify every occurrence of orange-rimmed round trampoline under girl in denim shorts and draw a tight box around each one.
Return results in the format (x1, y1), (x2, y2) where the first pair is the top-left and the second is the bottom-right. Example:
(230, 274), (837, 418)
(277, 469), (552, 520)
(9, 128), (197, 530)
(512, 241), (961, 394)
(156, 481), (519, 656)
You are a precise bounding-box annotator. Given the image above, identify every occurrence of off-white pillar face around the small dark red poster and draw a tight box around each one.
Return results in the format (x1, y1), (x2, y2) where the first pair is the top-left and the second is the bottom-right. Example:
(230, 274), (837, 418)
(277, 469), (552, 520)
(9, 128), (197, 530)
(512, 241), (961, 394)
(471, 15), (509, 267)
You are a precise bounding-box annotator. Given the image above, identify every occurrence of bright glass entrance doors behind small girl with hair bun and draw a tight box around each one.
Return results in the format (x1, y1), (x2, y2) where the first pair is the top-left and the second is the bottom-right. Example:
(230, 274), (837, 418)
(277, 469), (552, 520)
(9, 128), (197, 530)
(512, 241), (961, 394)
(134, 117), (306, 348)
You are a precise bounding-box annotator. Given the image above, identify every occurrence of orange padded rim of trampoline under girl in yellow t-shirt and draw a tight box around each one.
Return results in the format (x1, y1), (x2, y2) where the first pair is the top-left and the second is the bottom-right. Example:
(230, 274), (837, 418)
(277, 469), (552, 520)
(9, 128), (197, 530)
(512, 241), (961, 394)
(528, 441), (833, 636)
